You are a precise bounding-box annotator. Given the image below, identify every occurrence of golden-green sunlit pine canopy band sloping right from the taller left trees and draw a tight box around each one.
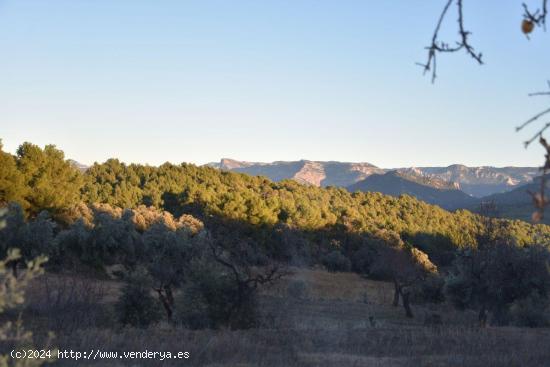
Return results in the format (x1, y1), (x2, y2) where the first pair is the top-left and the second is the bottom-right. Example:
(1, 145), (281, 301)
(83, 160), (525, 252)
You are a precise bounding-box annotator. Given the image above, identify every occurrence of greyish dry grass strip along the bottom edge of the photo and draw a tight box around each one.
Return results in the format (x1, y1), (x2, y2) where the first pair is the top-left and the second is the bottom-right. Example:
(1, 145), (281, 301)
(50, 327), (550, 367)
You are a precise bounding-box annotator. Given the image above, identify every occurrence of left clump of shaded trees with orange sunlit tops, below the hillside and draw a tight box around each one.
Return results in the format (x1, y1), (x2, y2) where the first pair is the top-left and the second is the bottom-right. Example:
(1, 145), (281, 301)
(49, 205), (203, 277)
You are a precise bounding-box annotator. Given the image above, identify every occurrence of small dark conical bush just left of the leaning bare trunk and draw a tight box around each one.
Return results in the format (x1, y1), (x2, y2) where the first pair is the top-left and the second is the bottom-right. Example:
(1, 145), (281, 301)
(115, 273), (161, 327)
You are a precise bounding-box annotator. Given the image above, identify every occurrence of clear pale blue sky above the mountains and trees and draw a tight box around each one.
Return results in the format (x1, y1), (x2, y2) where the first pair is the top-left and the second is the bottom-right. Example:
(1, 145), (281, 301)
(0, 0), (550, 168)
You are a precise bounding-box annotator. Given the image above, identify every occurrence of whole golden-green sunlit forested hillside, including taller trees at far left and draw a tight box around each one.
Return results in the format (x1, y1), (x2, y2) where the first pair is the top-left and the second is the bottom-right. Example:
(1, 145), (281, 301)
(0, 143), (550, 268)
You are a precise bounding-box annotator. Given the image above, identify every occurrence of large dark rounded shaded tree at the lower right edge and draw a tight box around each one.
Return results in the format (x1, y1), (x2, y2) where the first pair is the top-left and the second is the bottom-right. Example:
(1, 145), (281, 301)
(445, 239), (550, 326)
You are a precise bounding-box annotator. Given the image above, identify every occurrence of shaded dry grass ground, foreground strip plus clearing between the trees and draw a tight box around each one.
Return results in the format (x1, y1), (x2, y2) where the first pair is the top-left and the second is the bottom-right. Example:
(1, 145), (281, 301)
(10, 269), (550, 367)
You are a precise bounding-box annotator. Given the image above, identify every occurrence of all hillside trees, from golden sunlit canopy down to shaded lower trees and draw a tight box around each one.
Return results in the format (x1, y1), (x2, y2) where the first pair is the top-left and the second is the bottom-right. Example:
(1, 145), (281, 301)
(0, 143), (550, 328)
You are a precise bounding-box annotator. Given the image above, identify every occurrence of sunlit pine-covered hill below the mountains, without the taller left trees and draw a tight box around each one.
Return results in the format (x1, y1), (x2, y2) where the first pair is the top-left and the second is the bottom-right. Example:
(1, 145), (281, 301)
(82, 160), (550, 260)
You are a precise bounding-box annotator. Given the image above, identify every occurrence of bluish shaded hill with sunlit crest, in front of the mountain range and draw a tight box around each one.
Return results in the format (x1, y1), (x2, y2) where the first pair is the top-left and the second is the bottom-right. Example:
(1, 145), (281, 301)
(348, 171), (477, 210)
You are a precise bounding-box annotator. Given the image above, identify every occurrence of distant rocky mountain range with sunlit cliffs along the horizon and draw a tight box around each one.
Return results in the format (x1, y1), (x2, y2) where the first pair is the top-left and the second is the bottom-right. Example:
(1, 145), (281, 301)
(209, 158), (550, 223)
